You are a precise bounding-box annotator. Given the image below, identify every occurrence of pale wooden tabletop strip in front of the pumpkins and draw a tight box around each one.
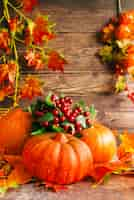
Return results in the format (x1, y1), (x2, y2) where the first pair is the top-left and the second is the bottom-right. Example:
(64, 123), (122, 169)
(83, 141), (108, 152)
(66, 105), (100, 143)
(0, 176), (134, 200)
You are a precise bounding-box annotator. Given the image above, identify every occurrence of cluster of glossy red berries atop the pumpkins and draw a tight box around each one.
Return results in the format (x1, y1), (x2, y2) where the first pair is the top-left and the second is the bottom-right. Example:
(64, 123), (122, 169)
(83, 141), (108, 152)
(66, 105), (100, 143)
(36, 95), (91, 134)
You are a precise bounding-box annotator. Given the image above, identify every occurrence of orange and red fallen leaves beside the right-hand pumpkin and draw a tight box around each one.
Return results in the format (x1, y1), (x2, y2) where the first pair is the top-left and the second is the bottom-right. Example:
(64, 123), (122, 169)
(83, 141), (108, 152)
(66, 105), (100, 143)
(92, 132), (134, 183)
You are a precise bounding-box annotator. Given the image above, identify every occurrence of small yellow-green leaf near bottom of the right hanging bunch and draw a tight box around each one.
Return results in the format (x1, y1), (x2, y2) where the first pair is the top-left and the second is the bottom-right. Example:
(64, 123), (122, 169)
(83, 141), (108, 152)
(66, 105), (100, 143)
(115, 76), (127, 92)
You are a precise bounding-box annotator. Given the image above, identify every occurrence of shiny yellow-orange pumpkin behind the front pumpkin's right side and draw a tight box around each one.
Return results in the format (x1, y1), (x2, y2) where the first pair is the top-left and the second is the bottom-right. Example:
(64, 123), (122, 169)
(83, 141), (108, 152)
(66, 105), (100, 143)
(81, 123), (117, 163)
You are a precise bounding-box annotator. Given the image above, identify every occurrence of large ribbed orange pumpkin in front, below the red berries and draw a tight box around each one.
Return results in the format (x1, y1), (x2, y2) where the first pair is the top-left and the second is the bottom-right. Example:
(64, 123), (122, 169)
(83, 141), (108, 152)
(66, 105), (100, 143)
(23, 133), (93, 184)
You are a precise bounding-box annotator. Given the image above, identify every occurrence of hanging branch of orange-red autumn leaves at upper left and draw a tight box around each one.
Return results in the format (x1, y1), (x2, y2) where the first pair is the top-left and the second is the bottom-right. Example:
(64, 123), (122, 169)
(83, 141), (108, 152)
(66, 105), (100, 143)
(0, 0), (67, 106)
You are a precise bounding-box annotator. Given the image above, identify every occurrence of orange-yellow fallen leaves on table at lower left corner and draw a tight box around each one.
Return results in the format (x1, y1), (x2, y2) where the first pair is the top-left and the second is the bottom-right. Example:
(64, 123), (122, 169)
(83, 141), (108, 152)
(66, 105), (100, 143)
(0, 155), (32, 190)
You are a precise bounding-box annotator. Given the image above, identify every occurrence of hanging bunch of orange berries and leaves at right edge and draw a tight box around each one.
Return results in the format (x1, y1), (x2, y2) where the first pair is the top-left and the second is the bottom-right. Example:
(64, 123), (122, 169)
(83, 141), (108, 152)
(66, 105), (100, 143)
(99, 10), (134, 102)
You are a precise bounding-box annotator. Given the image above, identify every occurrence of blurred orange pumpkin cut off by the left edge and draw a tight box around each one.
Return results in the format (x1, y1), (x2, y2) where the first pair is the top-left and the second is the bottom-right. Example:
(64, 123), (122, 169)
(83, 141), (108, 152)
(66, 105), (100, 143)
(0, 108), (31, 154)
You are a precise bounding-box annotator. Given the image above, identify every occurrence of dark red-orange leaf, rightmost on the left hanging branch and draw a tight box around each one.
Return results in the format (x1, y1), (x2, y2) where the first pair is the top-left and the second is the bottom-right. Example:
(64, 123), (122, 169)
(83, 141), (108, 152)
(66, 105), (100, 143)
(48, 51), (67, 71)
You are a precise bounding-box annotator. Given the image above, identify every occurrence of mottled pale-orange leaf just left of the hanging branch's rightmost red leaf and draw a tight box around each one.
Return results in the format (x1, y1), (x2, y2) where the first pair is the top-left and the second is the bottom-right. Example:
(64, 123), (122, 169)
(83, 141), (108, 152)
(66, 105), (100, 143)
(25, 50), (44, 70)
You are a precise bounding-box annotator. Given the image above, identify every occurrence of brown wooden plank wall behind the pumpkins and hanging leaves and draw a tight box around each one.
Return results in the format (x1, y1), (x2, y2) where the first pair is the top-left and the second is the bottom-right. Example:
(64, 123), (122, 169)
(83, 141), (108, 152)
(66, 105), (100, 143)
(2, 0), (134, 130)
